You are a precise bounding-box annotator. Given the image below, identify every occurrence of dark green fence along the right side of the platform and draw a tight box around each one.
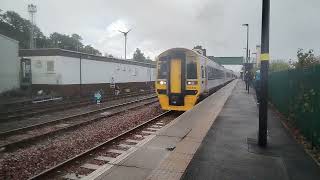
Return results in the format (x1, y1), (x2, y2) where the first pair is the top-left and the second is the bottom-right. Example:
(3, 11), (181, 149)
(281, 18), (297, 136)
(269, 65), (320, 146)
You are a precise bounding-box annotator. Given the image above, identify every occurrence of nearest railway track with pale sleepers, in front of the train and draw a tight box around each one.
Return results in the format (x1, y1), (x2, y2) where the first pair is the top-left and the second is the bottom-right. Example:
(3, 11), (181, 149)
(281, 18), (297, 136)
(29, 111), (177, 180)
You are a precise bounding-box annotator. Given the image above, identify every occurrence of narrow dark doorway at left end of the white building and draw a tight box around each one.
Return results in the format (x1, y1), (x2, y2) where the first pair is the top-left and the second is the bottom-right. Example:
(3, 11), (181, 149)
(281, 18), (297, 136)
(20, 58), (32, 88)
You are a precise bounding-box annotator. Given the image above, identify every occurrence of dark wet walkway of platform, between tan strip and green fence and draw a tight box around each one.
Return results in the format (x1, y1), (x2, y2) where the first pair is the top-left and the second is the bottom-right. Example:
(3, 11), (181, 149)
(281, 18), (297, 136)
(181, 81), (320, 180)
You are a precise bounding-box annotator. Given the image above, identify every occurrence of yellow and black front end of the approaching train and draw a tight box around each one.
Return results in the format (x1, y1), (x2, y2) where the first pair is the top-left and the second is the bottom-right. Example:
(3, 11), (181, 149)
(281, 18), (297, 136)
(155, 48), (201, 111)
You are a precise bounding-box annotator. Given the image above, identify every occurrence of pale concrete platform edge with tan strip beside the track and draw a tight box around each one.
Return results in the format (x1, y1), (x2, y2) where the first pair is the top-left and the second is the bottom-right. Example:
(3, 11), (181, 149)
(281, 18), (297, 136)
(96, 81), (237, 180)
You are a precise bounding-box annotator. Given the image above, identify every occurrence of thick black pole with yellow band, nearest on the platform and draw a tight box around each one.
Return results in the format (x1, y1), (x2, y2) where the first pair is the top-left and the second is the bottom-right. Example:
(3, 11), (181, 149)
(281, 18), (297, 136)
(258, 0), (270, 147)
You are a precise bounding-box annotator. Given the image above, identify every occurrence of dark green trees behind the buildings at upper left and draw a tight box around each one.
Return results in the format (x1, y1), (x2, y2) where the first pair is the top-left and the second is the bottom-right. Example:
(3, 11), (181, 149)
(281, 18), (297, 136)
(0, 11), (101, 55)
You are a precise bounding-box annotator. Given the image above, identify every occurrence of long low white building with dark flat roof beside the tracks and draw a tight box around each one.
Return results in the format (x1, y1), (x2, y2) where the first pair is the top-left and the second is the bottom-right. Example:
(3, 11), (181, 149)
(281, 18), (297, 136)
(20, 49), (155, 96)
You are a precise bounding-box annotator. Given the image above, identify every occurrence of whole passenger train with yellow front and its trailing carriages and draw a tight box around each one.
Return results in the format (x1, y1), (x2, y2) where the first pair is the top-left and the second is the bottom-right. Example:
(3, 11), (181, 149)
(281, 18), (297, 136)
(155, 48), (237, 111)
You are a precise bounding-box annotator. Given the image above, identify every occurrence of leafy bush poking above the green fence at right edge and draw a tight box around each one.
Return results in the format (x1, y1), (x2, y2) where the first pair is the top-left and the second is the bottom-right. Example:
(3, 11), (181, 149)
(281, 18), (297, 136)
(294, 49), (320, 69)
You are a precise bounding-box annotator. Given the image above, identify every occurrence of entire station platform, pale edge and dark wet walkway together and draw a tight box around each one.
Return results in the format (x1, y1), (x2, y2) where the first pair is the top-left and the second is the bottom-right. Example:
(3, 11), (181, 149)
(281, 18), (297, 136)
(94, 80), (320, 180)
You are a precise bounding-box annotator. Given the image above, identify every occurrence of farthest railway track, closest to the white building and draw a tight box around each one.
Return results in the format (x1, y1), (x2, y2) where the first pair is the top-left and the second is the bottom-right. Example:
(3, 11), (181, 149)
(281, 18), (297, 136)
(0, 91), (155, 122)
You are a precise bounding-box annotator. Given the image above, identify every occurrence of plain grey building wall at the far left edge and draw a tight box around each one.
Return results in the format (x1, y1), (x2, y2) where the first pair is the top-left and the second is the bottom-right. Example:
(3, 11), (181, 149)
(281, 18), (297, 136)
(0, 34), (20, 93)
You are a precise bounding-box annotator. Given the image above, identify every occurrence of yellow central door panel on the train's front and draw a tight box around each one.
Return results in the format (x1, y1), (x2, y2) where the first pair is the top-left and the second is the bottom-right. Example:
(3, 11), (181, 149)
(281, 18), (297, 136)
(170, 59), (181, 93)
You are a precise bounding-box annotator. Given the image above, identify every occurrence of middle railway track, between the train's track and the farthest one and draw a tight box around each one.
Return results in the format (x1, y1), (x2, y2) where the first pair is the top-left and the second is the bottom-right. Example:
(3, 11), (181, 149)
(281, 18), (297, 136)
(0, 96), (157, 151)
